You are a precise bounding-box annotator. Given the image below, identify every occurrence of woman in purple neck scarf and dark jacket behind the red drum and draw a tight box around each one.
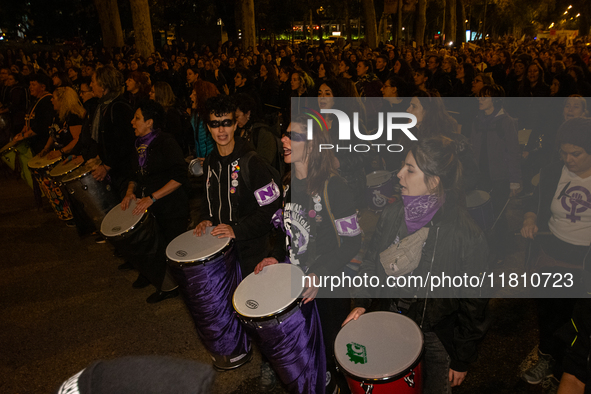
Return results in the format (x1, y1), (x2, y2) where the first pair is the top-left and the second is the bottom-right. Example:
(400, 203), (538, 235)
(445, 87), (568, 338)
(343, 136), (488, 394)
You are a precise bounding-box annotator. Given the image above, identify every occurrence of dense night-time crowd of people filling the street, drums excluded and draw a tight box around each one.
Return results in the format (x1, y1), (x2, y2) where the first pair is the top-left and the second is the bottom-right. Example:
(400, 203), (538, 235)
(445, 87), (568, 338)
(0, 40), (591, 393)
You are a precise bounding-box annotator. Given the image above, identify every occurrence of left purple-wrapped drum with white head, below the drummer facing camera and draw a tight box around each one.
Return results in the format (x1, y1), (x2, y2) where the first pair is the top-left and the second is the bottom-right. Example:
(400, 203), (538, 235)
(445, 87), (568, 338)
(166, 227), (252, 370)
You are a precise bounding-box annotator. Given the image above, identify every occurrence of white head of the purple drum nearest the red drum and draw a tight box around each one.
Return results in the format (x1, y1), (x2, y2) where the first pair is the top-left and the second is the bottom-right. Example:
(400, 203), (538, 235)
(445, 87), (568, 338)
(232, 264), (304, 318)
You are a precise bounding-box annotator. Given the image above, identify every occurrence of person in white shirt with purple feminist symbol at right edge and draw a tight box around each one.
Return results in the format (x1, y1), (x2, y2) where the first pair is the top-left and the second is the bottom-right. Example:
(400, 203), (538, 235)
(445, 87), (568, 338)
(521, 117), (591, 384)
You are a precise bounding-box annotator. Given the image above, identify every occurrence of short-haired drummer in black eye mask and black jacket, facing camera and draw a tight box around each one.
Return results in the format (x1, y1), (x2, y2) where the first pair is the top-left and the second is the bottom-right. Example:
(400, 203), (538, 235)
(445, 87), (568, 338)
(195, 96), (281, 276)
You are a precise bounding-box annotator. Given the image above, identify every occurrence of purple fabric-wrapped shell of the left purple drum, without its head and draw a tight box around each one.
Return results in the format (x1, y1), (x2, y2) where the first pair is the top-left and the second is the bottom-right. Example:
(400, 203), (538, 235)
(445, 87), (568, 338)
(168, 245), (250, 369)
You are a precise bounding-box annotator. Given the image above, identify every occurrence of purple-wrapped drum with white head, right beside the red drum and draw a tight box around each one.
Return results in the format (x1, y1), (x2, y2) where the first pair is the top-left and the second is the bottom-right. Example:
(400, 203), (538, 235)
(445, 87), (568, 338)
(233, 264), (326, 394)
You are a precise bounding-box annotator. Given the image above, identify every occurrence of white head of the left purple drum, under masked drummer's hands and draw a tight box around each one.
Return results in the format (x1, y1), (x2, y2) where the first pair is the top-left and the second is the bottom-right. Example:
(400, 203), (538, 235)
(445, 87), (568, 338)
(166, 227), (231, 263)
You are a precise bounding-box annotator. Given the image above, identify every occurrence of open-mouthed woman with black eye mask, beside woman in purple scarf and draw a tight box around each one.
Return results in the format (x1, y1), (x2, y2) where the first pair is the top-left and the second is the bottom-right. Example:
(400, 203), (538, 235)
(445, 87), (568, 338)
(255, 116), (362, 393)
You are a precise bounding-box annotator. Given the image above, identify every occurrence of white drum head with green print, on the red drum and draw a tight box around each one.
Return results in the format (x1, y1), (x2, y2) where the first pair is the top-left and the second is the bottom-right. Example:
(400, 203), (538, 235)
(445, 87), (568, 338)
(334, 312), (423, 380)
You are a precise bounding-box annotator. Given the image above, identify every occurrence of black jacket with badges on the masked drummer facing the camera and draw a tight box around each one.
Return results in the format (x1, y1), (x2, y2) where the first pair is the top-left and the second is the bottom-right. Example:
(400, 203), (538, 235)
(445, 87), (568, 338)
(201, 137), (282, 276)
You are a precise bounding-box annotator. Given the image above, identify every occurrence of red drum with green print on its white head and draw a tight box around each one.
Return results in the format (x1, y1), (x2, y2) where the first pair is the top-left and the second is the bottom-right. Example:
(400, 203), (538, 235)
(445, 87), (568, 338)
(334, 312), (423, 394)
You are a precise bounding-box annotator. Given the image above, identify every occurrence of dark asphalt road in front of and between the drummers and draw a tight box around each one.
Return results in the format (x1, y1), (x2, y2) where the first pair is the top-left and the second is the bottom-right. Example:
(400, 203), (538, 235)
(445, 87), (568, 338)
(0, 176), (556, 394)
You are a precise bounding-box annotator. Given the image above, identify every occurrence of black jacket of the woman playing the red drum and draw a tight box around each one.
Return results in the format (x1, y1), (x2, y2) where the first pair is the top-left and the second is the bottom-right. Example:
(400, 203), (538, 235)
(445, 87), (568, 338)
(352, 196), (488, 372)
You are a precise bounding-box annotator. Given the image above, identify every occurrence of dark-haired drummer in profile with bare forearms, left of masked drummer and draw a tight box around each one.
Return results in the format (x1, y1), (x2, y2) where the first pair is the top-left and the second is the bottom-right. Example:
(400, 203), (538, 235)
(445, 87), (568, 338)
(121, 100), (189, 304)
